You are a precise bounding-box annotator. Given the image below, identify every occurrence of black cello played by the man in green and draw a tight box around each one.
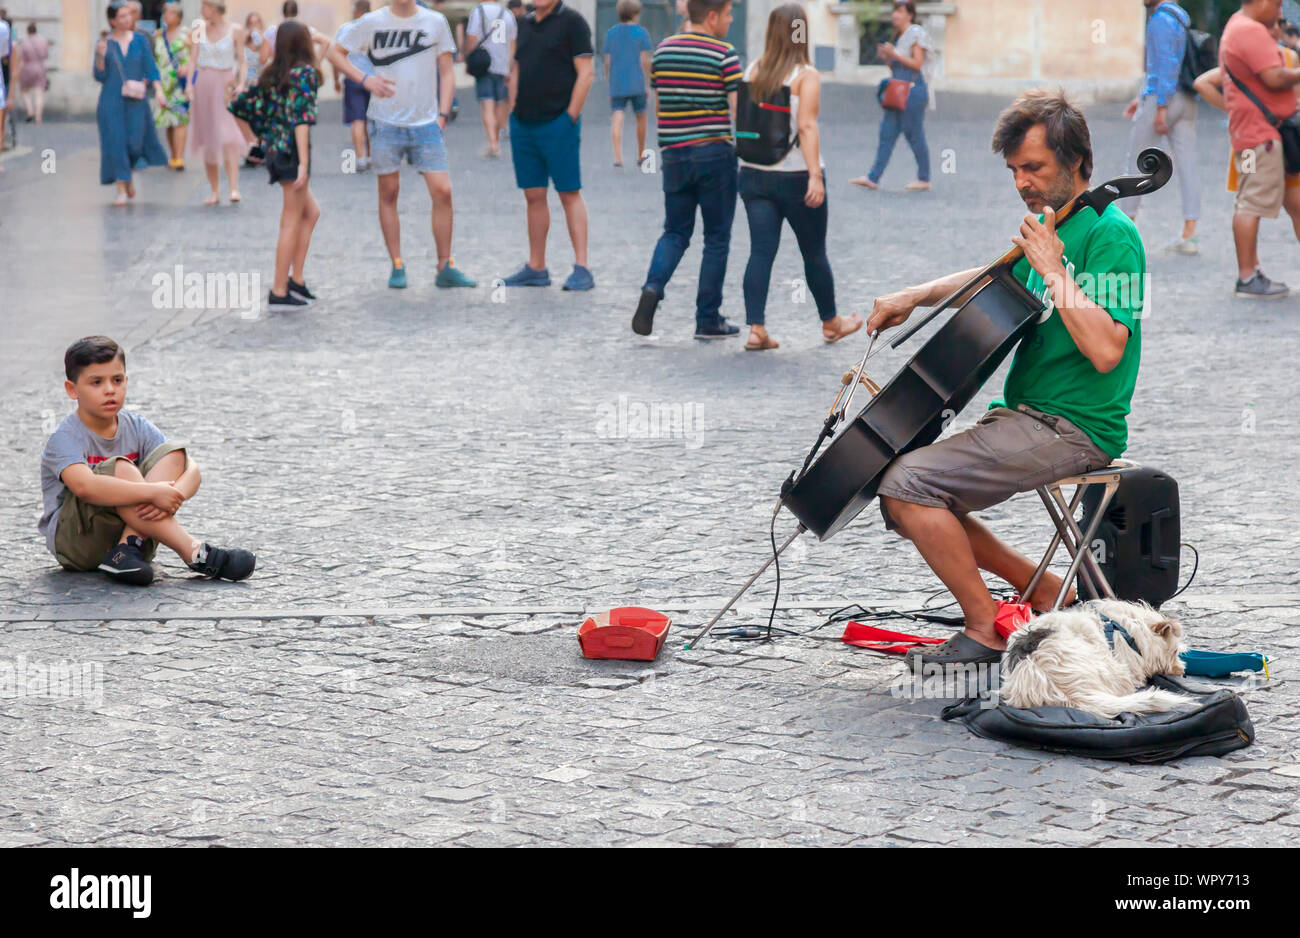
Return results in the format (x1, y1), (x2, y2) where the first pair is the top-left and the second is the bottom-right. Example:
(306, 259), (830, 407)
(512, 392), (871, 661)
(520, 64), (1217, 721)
(686, 147), (1174, 648)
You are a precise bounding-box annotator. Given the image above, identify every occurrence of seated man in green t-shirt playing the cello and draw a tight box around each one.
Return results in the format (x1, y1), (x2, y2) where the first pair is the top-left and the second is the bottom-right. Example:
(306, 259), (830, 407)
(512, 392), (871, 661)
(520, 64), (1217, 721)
(867, 90), (1147, 664)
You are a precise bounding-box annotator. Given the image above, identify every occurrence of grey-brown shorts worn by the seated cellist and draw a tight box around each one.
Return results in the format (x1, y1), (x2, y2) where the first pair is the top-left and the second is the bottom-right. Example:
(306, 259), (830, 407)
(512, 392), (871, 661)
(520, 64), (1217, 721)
(878, 404), (1110, 530)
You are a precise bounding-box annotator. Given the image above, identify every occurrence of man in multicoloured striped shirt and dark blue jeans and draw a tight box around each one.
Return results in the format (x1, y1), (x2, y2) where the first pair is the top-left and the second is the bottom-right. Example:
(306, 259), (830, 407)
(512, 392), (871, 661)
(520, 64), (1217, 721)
(632, 0), (741, 339)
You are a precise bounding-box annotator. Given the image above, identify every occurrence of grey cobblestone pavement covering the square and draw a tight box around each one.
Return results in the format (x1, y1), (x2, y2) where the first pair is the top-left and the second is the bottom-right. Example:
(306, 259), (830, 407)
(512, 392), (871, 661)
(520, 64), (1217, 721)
(0, 87), (1300, 846)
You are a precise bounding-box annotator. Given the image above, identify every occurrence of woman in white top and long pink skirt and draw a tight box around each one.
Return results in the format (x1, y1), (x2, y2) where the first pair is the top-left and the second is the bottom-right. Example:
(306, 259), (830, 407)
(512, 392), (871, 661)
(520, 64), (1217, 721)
(186, 0), (248, 205)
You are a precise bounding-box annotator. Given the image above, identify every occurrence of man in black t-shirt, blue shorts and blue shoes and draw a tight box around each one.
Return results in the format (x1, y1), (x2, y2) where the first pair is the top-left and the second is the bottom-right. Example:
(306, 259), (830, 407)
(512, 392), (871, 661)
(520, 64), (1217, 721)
(506, 0), (595, 290)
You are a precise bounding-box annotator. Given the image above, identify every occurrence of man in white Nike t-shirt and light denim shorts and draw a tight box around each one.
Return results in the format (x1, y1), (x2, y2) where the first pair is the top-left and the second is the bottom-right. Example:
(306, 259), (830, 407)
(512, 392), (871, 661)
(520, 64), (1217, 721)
(328, 0), (477, 288)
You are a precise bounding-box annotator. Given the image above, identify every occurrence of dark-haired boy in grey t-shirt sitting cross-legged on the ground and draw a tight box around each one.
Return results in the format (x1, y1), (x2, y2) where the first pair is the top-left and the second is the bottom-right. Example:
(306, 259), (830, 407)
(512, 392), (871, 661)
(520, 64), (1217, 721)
(38, 335), (256, 586)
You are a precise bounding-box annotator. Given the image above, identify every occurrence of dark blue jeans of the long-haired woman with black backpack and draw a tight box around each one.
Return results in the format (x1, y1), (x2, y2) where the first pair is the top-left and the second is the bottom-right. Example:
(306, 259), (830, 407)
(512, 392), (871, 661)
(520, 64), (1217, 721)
(740, 166), (835, 326)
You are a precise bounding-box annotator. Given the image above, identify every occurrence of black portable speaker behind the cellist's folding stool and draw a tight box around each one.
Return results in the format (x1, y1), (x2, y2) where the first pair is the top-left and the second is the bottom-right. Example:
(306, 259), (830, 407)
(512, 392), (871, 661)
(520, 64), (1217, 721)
(1076, 466), (1182, 608)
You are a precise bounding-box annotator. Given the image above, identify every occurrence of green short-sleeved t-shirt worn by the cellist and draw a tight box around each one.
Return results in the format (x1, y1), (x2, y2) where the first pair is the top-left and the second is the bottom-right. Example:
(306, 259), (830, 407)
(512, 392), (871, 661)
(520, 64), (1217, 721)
(993, 203), (1147, 459)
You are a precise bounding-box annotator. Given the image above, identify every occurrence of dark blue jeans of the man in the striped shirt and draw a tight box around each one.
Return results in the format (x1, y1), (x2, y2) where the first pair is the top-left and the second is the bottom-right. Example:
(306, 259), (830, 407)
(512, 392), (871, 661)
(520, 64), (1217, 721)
(644, 143), (736, 329)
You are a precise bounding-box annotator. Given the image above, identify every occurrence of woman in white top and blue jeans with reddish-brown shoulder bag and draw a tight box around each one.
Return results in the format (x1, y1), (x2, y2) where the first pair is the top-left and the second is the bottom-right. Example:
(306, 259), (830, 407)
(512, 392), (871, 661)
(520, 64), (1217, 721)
(849, 0), (933, 192)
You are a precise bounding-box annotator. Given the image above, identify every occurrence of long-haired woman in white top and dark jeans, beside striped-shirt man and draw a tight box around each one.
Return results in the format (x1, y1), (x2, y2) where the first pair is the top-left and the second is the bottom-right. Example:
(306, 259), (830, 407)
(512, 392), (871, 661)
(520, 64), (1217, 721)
(740, 3), (862, 352)
